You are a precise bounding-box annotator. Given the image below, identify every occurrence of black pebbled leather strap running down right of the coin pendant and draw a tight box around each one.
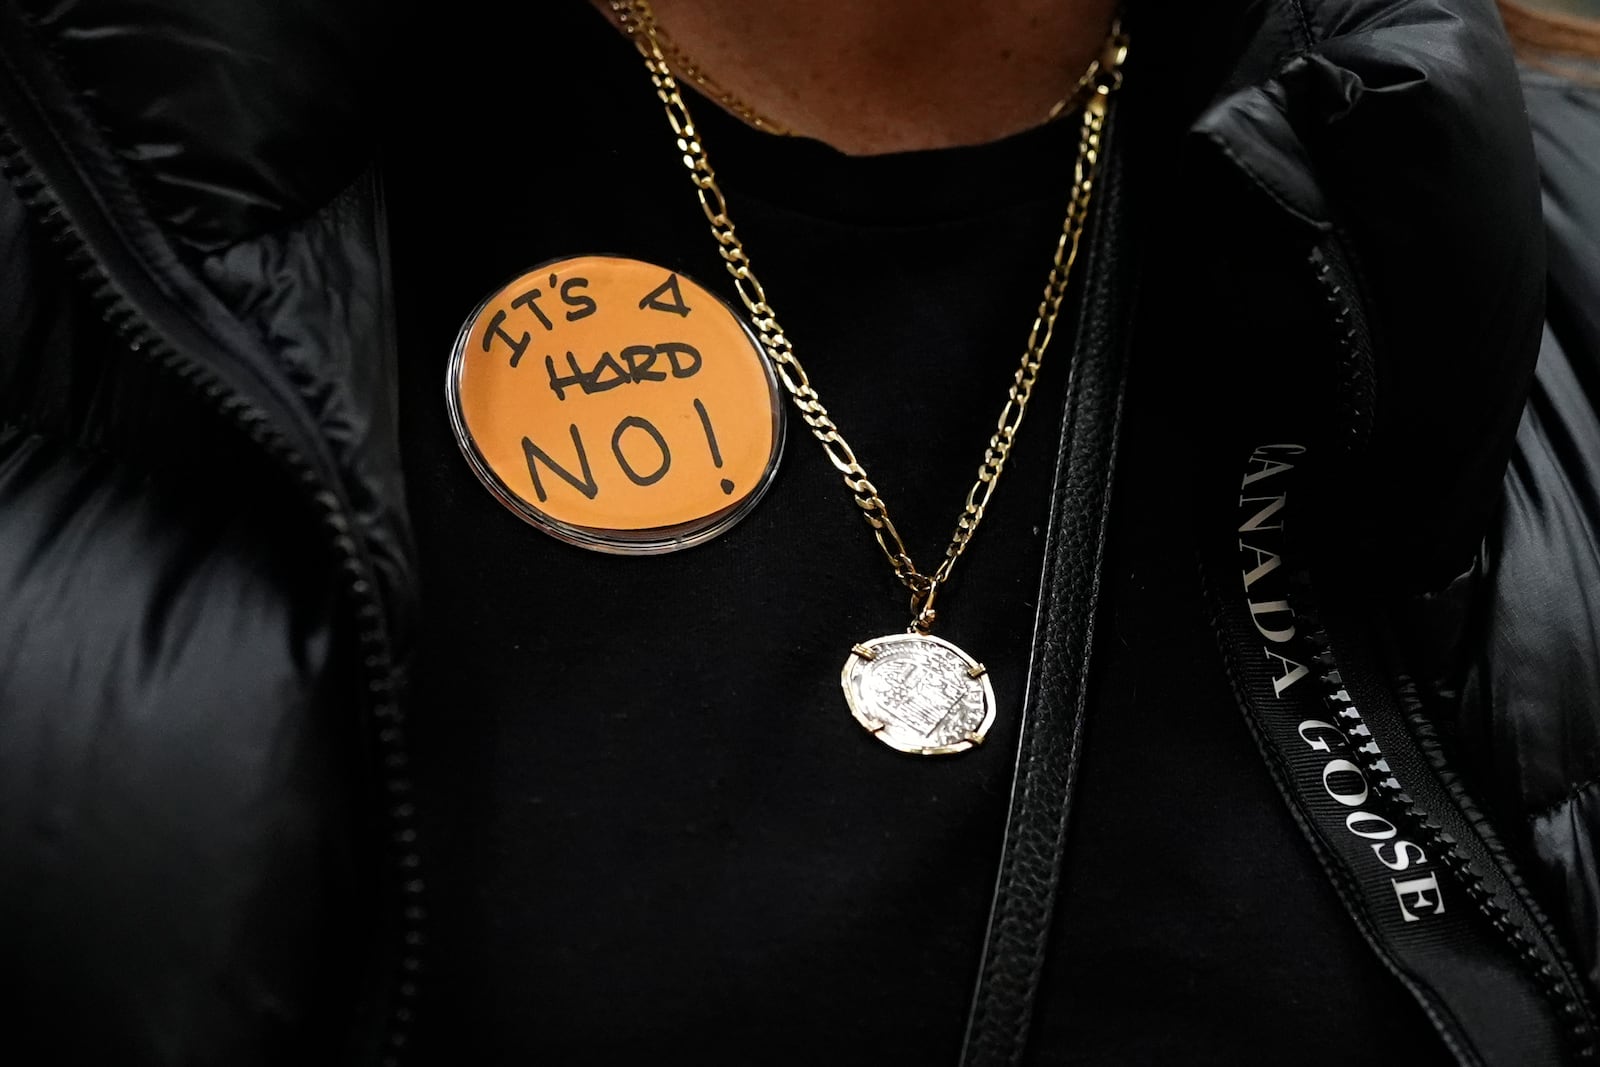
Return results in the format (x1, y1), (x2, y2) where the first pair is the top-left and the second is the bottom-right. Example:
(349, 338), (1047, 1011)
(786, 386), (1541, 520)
(962, 93), (1134, 1067)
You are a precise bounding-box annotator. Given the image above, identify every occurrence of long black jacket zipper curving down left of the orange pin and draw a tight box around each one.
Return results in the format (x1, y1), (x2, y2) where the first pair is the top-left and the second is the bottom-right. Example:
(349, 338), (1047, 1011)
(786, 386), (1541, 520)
(0, 77), (426, 1067)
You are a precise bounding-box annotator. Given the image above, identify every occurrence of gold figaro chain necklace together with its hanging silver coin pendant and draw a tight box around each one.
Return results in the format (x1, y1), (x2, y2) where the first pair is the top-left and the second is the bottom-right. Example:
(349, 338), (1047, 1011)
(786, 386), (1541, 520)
(610, 0), (1128, 755)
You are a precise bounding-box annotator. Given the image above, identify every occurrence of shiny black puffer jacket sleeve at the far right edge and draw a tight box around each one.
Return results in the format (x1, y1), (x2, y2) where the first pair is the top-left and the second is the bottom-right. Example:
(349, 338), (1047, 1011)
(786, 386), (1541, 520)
(1462, 74), (1600, 995)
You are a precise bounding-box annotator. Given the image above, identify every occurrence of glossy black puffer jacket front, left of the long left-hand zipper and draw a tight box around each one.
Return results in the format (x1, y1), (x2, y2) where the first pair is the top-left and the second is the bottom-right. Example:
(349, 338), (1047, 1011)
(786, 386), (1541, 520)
(0, 171), (372, 1067)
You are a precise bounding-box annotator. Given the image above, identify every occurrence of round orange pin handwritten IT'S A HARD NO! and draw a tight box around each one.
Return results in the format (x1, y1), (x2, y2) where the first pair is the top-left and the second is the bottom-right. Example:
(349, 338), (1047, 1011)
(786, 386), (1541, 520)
(446, 256), (784, 553)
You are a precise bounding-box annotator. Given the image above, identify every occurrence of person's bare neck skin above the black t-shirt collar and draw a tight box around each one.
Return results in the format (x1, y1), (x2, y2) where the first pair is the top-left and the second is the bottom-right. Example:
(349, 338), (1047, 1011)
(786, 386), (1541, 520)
(590, 0), (1117, 155)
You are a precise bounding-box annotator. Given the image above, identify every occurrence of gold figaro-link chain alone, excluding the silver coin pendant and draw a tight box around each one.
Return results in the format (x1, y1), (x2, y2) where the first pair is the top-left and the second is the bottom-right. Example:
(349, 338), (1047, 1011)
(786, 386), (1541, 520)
(610, 0), (1128, 633)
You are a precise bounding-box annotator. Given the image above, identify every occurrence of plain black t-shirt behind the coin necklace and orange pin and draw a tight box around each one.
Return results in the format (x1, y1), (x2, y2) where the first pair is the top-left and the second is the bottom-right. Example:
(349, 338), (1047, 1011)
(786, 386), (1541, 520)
(389, 2), (1445, 1064)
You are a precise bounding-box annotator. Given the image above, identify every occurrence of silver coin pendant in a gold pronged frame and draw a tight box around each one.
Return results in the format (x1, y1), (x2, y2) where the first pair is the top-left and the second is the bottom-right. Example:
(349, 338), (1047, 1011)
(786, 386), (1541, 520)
(840, 630), (995, 755)
